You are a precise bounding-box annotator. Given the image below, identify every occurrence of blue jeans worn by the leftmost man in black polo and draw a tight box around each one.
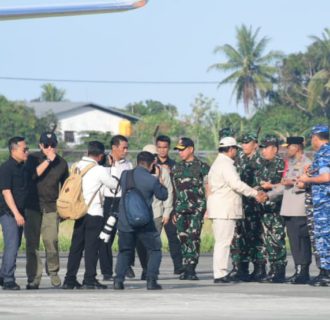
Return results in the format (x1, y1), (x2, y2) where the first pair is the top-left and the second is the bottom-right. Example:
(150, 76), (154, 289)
(0, 213), (23, 283)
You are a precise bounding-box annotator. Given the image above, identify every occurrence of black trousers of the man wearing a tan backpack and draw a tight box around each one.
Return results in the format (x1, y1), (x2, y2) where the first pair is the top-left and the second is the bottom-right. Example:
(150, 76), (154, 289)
(65, 214), (103, 284)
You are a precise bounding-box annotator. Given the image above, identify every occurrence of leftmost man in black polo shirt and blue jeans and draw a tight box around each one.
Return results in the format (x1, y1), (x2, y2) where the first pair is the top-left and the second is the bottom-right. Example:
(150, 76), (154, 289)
(0, 137), (29, 290)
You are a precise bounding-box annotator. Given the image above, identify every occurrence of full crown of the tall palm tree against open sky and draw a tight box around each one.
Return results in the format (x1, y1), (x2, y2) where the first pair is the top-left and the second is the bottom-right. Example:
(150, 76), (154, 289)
(209, 24), (283, 113)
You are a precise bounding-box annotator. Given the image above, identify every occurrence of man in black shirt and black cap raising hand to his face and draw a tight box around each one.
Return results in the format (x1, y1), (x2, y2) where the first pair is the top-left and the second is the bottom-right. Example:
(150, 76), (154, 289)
(25, 132), (68, 289)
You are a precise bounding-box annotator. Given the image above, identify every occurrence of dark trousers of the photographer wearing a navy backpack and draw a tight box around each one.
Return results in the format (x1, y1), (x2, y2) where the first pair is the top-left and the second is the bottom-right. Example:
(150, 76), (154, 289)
(116, 228), (162, 281)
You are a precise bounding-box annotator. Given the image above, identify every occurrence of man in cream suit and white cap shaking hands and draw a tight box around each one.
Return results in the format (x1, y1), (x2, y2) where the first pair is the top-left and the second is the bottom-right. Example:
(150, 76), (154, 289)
(207, 137), (266, 283)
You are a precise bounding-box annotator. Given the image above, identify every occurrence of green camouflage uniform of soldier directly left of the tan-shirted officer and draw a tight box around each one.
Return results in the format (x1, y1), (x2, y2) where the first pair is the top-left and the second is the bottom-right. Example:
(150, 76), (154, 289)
(256, 155), (286, 269)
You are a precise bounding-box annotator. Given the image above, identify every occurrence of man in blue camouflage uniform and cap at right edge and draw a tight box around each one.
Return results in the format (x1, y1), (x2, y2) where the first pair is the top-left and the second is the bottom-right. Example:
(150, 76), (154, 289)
(299, 125), (330, 286)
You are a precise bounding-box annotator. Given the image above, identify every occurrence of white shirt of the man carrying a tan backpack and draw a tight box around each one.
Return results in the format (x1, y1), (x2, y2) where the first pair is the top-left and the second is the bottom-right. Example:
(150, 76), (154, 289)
(77, 157), (117, 216)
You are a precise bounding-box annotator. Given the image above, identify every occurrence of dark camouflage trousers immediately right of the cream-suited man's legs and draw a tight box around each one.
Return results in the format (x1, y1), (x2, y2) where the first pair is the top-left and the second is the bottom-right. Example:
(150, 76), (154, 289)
(230, 206), (266, 265)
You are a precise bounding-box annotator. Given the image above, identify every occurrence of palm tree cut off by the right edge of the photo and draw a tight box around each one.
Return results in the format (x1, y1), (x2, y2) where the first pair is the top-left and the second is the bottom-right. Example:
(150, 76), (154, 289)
(307, 28), (330, 116)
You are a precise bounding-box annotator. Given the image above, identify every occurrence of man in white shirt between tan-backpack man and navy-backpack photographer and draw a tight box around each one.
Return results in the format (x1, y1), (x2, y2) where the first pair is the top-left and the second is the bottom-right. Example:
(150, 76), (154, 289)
(99, 135), (134, 281)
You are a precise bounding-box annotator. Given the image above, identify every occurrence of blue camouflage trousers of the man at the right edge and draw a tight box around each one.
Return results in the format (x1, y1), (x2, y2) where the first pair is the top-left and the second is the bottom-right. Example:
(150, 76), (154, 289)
(314, 201), (330, 270)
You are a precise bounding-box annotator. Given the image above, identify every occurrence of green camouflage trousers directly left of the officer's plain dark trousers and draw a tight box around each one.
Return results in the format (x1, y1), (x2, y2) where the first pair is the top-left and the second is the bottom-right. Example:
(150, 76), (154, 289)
(261, 212), (286, 265)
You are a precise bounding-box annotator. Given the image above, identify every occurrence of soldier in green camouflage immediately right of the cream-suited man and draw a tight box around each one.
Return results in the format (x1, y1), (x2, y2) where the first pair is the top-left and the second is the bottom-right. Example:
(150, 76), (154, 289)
(231, 133), (266, 281)
